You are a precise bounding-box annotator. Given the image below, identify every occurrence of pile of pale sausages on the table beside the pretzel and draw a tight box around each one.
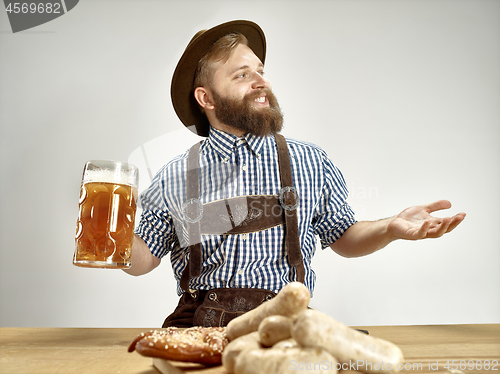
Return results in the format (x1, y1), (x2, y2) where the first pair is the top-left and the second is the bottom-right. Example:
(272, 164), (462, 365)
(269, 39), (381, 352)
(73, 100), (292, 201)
(222, 282), (404, 374)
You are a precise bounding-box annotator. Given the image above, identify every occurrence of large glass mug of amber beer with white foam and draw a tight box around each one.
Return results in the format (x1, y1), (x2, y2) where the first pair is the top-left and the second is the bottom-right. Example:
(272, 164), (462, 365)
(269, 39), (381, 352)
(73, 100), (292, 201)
(73, 161), (139, 269)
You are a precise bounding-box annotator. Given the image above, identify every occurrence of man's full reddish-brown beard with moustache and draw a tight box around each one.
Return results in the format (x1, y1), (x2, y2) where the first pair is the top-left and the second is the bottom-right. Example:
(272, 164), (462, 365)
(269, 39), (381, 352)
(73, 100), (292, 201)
(212, 88), (283, 136)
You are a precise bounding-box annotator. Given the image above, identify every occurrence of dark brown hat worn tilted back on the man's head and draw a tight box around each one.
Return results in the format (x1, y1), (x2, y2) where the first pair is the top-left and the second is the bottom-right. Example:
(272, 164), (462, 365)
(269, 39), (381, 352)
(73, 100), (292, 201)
(170, 20), (266, 137)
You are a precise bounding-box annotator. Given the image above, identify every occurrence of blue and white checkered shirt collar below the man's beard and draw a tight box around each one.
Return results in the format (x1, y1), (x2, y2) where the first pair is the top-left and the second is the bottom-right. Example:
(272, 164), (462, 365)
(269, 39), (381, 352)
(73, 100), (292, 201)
(208, 126), (266, 159)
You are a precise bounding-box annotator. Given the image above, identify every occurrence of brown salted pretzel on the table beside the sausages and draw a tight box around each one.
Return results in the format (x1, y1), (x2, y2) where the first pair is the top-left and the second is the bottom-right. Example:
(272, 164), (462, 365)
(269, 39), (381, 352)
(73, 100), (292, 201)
(128, 326), (228, 365)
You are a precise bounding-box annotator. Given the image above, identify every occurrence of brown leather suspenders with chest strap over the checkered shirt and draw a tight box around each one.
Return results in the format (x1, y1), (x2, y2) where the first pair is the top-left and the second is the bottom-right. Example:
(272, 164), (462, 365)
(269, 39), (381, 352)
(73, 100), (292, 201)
(180, 134), (304, 291)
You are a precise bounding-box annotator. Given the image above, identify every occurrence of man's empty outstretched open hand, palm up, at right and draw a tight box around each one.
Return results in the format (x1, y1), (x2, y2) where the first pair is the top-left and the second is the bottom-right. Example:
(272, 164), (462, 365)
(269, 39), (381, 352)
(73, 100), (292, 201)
(388, 200), (465, 240)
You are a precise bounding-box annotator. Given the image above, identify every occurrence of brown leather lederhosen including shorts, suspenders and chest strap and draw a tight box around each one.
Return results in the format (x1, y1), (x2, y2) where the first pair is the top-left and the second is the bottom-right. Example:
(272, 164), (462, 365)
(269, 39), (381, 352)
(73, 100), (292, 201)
(162, 134), (304, 327)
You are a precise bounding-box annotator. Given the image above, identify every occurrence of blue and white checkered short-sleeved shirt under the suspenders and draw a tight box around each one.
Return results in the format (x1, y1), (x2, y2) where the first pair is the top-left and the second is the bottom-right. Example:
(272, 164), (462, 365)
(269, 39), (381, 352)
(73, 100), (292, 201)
(136, 128), (356, 295)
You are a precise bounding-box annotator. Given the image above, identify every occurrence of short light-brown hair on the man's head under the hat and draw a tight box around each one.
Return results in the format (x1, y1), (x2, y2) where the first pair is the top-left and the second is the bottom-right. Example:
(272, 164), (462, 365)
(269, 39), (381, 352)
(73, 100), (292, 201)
(193, 32), (248, 88)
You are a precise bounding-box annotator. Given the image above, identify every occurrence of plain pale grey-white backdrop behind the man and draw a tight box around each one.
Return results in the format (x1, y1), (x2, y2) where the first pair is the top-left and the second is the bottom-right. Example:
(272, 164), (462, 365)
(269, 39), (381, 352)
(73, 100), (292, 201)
(0, 0), (500, 327)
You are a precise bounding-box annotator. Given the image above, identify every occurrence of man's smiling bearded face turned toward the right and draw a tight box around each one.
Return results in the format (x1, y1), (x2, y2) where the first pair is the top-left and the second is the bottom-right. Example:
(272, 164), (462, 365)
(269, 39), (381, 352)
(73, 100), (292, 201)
(210, 44), (283, 136)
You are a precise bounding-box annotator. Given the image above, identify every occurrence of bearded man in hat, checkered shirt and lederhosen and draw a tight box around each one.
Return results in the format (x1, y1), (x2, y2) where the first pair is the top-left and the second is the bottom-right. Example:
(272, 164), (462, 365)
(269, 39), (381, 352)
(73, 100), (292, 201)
(126, 21), (465, 327)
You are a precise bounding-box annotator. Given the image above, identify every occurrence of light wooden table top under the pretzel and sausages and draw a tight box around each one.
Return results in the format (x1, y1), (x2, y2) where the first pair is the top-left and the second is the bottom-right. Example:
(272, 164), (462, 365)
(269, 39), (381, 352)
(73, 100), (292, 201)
(0, 324), (500, 374)
